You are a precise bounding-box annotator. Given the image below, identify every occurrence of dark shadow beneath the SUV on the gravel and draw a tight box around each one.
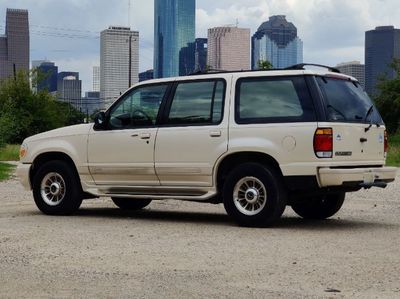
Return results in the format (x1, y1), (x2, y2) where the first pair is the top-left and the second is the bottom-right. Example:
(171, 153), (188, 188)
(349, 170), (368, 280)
(65, 207), (400, 231)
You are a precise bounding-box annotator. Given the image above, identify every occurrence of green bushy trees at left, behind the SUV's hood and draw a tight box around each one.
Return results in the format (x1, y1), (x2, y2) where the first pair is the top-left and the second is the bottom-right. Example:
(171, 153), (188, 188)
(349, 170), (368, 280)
(0, 71), (84, 144)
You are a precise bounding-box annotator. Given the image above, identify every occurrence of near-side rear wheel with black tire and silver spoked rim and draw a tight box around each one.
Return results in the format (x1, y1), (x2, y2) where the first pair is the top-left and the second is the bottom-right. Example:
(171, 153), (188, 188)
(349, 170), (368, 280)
(222, 163), (287, 227)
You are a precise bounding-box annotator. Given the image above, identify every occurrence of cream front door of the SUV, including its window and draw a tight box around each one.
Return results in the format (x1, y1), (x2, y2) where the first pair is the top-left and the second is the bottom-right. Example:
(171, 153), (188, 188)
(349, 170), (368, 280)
(88, 84), (168, 186)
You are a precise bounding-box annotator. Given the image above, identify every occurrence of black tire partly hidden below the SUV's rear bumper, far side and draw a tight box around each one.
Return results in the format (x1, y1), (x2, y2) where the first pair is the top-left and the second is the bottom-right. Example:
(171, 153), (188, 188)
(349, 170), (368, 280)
(292, 192), (346, 219)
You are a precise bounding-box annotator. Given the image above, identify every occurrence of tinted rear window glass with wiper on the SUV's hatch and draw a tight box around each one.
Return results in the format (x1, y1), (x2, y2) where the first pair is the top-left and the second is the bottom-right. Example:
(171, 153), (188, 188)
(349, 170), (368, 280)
(317, 77), (383, 124)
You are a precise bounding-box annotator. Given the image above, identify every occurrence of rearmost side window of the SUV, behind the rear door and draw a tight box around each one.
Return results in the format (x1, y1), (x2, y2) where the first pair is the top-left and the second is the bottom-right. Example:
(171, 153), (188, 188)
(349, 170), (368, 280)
(235, 77), (316, 124)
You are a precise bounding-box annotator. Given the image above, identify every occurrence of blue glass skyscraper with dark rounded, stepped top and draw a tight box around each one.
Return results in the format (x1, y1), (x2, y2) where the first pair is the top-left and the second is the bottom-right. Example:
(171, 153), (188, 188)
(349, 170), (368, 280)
(251, 15), (303, 69)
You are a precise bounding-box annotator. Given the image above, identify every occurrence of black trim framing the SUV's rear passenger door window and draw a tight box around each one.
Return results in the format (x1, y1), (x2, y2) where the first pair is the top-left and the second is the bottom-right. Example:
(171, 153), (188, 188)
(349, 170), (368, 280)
(159, 77), (227, 128)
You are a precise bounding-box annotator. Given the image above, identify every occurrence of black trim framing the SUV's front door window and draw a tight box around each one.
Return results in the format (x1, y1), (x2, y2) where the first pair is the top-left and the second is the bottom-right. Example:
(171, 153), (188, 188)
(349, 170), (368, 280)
(102, 81), (174, 131)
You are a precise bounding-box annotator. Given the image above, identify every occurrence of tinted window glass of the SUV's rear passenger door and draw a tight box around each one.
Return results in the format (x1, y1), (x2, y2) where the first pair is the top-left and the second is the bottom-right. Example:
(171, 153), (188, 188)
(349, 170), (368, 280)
(167, 80), (225, 125)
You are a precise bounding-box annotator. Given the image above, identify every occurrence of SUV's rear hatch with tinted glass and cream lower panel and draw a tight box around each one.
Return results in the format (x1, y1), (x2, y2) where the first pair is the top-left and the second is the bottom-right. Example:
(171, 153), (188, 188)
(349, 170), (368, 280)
(316, 75), (385, 165)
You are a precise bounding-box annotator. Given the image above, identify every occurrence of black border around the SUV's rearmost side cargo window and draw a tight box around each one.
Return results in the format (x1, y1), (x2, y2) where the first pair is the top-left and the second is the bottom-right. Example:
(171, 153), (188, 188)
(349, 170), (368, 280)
(235, 75), (318, 125)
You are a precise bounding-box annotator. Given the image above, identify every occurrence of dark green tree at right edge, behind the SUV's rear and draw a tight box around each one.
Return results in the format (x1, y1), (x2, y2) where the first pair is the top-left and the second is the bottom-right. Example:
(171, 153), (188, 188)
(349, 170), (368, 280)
(374, 59), (400, 133)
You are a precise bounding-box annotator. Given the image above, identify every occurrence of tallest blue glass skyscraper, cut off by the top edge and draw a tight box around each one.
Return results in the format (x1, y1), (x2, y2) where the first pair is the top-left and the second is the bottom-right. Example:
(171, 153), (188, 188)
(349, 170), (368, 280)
(154, 0), (196, 78)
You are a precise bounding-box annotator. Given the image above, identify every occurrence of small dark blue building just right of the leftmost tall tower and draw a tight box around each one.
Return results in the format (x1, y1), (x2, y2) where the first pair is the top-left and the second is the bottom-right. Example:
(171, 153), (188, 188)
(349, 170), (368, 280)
(32, 60), (58, 92)
